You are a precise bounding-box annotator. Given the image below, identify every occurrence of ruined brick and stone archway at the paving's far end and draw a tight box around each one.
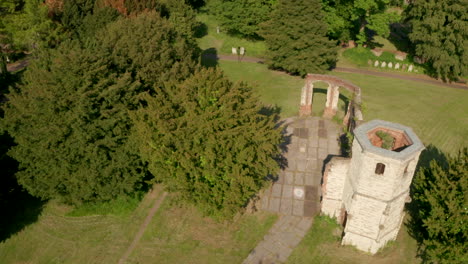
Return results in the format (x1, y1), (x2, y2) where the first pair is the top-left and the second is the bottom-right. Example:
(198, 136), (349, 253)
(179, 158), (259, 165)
(299, 74), (363, 129)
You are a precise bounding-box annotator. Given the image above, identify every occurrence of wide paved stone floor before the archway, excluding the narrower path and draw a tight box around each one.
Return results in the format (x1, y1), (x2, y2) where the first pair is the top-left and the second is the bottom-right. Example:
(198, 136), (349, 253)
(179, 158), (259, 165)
(261, 117), (340, 216)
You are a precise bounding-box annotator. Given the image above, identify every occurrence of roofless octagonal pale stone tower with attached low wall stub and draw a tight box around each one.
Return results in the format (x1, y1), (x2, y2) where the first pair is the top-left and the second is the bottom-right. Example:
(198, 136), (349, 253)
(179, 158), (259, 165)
(321, 120), (424, 254)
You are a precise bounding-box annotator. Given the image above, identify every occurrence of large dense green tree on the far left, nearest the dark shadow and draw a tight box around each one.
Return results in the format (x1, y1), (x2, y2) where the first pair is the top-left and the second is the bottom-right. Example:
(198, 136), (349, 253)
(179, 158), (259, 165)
(4, 43), (145, 204)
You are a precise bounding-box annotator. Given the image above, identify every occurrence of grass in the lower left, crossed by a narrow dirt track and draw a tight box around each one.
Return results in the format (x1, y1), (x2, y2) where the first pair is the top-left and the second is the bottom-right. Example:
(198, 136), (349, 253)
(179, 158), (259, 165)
(0, 188), (276, 264)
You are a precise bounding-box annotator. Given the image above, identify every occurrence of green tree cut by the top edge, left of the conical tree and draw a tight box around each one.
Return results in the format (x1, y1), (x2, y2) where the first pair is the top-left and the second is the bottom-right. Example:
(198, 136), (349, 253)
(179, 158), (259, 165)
(208, 0), (277, 38)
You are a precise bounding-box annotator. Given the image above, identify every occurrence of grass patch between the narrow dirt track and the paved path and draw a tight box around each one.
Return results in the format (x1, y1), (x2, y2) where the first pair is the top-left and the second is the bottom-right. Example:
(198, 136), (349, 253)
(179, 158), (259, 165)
(128, 201), (277, 264)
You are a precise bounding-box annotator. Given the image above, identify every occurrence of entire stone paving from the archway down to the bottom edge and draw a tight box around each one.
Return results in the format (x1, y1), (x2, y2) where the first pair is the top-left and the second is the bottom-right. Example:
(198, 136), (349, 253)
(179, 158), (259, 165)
(244, 117), (340, 264)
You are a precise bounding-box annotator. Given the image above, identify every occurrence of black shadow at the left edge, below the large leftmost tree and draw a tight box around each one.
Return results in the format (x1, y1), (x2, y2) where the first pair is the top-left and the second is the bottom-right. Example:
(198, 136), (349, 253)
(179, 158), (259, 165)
(0, 132), (45, 242)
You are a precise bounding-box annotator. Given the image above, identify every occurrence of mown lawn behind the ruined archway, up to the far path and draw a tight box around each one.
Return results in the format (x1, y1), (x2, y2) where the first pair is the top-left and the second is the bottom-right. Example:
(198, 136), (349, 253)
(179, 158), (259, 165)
(219, 61), (468, 154)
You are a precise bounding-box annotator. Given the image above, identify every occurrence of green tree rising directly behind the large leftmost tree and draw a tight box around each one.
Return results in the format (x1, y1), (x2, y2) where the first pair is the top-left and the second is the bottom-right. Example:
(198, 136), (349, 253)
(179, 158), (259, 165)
(96, 12), (200, 87)
